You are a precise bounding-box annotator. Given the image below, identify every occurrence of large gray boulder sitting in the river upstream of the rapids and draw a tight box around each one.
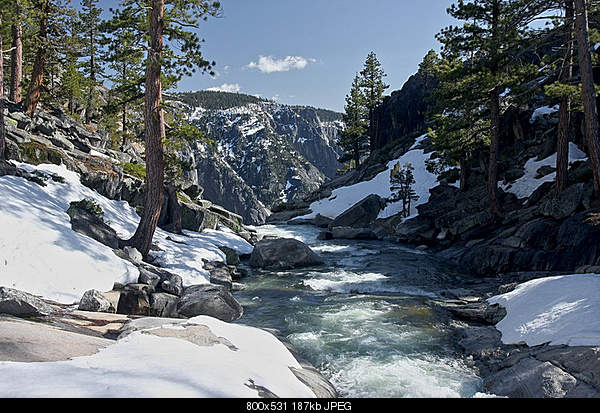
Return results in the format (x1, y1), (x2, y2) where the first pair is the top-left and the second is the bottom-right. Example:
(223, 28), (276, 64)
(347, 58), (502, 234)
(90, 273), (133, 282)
(250, 238), (324, 270)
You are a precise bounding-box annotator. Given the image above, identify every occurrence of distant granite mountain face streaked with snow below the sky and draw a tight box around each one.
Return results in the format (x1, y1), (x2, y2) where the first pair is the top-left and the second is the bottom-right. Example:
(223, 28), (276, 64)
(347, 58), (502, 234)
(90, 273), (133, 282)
(172, 91), (343, 224)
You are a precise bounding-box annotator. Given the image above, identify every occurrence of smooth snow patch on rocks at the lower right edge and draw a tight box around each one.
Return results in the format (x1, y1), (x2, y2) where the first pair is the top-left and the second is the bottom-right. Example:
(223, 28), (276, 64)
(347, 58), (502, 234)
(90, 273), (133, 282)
(488, 274), (600, 346)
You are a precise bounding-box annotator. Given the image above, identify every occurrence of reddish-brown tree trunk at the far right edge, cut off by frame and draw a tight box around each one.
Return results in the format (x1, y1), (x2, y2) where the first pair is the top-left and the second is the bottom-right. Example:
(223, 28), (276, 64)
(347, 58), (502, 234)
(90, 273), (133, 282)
(575, 0), (600, 195)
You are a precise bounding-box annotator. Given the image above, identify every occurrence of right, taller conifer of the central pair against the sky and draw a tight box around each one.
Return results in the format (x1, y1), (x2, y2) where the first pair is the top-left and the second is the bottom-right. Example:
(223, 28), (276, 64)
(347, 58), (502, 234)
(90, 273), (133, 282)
(360, 52), (390, 148)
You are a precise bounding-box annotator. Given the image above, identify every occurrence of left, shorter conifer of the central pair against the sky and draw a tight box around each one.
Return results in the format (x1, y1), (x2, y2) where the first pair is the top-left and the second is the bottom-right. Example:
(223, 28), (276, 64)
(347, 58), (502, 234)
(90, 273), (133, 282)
(337, 75), (369, 169)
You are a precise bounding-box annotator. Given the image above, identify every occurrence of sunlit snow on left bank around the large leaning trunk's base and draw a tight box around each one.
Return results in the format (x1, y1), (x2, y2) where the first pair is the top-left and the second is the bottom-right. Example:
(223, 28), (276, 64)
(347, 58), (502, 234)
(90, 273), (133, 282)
(0, 163), (252, 303)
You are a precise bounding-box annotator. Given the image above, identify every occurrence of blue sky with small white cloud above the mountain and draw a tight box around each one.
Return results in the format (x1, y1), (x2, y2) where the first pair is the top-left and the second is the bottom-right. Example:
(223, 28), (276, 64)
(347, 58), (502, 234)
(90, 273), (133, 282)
(97, 0), (453, 111)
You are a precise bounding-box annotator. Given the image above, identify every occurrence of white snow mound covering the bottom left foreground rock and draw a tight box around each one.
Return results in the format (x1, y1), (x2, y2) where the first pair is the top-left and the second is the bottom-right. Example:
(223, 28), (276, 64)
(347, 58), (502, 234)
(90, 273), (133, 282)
(0, 316), (315, 398)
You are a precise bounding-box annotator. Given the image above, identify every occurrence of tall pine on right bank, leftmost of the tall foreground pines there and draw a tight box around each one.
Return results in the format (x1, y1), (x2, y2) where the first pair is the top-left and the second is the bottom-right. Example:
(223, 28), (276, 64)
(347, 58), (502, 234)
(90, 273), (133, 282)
(437, 0), (546, 217)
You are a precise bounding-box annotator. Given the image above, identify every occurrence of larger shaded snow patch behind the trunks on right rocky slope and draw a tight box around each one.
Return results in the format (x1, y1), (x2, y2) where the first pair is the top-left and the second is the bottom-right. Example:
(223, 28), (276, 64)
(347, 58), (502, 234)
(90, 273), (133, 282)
(500, 142), (587, 199)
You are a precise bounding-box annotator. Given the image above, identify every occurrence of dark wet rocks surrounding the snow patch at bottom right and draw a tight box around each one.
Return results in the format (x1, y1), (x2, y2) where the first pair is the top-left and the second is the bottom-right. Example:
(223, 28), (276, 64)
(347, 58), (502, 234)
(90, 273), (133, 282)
(434, 273), (600, 398)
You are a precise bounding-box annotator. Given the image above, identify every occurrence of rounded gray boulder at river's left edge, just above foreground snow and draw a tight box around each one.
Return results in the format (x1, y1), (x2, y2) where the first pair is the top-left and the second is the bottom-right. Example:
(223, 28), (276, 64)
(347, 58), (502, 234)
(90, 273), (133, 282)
(177, 284), (244, 322)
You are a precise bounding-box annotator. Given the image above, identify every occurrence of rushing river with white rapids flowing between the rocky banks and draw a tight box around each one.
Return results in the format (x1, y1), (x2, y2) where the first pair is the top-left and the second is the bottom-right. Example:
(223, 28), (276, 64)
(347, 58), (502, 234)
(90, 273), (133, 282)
(236, 226), (488, 397)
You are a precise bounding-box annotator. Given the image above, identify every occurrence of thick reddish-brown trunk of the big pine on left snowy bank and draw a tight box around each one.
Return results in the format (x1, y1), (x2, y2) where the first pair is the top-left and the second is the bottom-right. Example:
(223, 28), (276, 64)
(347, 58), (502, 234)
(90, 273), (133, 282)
(125, 0), (165, 258)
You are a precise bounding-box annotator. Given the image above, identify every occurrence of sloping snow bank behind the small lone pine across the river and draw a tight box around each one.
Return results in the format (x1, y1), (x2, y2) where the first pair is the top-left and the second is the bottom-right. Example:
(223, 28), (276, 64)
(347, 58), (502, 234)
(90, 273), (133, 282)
(292, 135), (452, 221)
